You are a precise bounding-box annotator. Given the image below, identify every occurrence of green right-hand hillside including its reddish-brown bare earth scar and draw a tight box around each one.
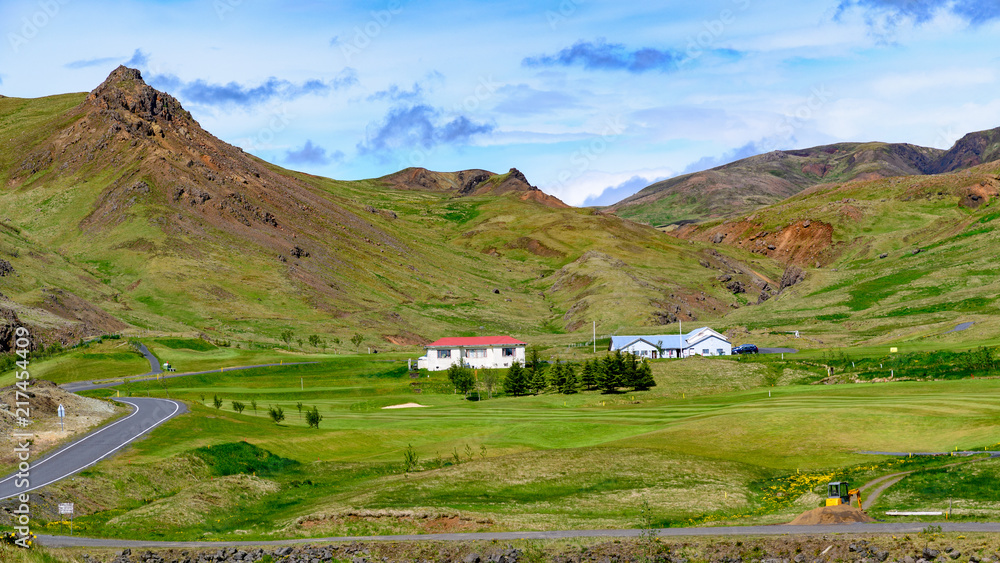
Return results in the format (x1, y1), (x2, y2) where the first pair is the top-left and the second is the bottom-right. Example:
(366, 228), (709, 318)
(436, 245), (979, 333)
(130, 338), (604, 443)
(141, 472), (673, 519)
(671, 154), (1000, 347)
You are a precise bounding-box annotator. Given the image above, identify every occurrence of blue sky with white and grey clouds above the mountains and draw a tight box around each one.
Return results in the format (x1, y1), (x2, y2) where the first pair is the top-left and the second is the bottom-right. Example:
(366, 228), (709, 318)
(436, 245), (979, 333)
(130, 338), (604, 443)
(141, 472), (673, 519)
(0, 0), (1000, 205)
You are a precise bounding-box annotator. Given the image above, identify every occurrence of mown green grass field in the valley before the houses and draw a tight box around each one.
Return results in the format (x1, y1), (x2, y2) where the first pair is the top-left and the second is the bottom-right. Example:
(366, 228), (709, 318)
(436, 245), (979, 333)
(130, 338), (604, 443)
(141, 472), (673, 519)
(29, 351), (1000, 539)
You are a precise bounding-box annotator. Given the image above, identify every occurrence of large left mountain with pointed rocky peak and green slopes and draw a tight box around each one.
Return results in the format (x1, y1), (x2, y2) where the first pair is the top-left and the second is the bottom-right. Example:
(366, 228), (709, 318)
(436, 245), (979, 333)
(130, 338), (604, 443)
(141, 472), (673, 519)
(0, 67), (756, 347)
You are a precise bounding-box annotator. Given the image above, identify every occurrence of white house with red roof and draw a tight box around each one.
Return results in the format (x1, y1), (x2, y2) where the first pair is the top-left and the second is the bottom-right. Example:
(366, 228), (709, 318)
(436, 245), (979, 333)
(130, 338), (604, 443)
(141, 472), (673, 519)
(417, 336), (528, 371)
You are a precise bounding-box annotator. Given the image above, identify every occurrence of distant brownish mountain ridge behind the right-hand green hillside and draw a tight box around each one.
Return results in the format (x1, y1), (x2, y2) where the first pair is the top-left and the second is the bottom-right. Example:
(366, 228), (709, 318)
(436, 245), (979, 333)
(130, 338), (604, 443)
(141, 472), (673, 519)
(605, 129), (1000, 225)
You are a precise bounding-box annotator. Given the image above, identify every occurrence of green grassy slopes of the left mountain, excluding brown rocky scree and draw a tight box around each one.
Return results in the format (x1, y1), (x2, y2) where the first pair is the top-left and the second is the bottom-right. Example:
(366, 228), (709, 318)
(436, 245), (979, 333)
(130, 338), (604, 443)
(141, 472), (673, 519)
(0, 94), (760, 347)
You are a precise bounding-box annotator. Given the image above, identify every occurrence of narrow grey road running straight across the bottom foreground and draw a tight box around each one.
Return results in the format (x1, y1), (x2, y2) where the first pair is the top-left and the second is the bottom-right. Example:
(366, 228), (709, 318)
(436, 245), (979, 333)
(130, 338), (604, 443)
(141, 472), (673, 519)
(38, 522), (1000, 548)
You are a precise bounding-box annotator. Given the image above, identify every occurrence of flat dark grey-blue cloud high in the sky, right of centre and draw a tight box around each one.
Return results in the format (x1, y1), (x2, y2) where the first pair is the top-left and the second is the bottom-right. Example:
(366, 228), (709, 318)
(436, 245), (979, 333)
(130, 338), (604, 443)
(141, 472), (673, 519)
(521, 39), (684, 73)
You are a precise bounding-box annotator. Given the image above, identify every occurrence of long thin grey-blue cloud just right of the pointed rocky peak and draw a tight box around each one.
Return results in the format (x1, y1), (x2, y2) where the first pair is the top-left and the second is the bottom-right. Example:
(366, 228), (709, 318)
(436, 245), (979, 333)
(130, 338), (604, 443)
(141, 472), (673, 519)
(150, 68), (358, 107)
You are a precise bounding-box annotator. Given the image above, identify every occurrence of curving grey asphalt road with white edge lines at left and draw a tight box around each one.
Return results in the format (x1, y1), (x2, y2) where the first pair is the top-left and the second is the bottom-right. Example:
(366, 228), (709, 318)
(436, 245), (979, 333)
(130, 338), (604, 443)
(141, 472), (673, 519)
(0, 397), (187, 499)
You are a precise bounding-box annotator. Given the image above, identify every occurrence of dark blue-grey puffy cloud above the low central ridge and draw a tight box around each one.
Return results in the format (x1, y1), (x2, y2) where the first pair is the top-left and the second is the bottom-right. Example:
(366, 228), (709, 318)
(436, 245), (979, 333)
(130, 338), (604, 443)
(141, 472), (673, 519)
(358, 104), (496, 154)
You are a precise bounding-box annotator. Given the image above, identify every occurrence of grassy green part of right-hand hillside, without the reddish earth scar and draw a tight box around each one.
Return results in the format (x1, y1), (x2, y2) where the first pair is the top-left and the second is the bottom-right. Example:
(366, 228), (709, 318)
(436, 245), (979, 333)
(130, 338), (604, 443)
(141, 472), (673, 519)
(700, 163), (1000, 352)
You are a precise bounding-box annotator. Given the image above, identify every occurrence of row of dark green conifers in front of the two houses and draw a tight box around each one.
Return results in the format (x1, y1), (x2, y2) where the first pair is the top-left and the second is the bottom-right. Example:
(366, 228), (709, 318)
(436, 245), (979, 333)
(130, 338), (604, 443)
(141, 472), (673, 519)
(448, 349), (656, 398)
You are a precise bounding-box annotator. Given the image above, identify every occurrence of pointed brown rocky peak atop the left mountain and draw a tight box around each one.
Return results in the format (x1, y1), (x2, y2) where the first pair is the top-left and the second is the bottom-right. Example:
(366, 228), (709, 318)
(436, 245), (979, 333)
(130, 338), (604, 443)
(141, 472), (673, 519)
(87, 66), (191, 121)
